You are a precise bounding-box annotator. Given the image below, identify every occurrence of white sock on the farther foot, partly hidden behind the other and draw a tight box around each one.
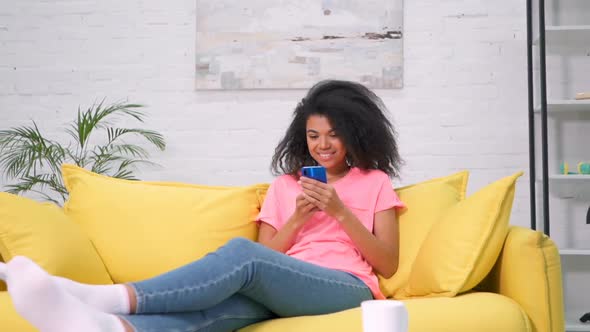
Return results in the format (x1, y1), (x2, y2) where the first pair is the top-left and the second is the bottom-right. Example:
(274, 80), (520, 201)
(52, 277), (131, 315)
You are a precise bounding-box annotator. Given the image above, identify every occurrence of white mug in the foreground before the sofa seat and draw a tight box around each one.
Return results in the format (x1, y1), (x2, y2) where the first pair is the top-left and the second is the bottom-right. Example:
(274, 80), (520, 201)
(361, 300), (408, 332)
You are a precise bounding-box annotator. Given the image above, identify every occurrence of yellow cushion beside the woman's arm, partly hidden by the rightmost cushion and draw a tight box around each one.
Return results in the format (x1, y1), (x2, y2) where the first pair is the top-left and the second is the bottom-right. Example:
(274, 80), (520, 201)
(379, 171), (469, 298)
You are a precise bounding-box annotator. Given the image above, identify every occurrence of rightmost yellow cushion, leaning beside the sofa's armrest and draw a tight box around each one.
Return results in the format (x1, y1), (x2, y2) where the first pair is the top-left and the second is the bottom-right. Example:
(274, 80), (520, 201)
(395, 172), (522, 298)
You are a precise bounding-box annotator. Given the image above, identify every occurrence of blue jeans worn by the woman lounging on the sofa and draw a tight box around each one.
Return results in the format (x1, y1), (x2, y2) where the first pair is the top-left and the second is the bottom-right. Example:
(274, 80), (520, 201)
(121, 238), (373, 332)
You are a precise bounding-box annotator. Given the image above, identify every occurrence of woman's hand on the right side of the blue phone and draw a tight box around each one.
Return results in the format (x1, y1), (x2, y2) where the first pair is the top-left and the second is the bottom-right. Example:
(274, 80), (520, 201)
(299, 176), (348, 219)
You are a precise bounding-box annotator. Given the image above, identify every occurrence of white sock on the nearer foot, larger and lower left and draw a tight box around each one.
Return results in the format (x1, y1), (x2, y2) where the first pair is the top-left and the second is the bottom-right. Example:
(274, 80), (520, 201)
(7, 256), (125, 332)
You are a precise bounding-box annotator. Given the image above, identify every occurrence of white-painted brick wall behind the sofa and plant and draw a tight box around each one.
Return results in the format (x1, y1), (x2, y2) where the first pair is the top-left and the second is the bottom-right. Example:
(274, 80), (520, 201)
(0, 0), (529, 226)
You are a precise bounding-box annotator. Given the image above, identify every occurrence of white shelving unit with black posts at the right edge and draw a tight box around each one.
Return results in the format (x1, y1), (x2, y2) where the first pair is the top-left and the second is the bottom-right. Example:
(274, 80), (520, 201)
(529, 0), (590, 332)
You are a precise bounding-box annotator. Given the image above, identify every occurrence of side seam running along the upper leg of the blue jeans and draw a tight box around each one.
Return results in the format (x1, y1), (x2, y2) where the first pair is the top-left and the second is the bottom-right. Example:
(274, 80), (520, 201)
(138, 258), (368, 311)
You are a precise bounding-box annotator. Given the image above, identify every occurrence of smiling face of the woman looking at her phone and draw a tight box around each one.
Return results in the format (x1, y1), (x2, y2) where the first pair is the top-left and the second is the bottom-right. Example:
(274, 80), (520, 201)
(305, 115), (348, 175)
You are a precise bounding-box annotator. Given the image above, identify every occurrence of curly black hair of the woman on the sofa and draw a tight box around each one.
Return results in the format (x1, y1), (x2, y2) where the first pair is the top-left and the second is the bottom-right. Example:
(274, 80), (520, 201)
(271, 80), (402, 177)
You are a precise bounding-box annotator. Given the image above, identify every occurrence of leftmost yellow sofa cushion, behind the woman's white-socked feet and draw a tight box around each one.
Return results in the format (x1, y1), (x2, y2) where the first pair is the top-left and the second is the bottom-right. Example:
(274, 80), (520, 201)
(0, 192), (112, 290)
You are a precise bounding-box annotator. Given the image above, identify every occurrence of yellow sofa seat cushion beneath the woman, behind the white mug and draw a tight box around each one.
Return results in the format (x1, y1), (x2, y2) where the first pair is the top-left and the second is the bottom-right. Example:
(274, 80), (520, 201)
(239, 293), (532, 332)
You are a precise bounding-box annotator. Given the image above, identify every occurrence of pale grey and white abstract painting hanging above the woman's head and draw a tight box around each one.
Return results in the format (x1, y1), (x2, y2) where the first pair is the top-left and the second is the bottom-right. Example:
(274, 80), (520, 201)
(195, 0), (403, 90)
